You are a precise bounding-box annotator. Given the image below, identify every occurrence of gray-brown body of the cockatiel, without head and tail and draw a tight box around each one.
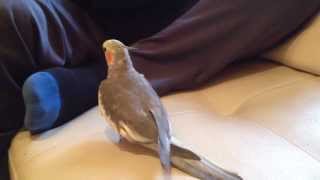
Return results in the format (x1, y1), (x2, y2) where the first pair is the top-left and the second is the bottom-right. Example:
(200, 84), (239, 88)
(99, 71), (170, 144)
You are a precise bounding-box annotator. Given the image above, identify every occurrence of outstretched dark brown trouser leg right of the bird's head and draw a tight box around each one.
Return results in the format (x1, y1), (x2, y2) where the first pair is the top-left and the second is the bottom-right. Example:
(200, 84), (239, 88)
(131, 0), (320, 95)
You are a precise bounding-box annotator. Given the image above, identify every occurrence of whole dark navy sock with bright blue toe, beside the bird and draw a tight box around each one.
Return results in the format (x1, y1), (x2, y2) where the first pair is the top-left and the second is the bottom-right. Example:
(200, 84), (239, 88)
(23, 63), (106, 134)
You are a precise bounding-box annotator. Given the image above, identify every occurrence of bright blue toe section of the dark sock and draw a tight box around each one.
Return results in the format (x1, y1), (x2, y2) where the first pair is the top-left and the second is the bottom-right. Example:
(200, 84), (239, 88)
(22, 72), (61, 134)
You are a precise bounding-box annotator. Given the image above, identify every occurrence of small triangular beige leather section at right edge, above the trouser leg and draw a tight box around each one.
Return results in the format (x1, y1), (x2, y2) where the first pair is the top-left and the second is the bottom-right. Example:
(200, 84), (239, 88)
(266, 12), (320, 75)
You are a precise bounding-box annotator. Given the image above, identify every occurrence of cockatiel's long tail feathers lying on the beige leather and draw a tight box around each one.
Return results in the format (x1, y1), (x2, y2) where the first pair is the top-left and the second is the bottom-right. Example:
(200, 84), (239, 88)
(171, 138), (242, 180)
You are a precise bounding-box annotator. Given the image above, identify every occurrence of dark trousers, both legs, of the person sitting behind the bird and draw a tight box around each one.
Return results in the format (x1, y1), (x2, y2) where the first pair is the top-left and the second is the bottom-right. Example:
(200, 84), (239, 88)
(0, 0), (320, 179)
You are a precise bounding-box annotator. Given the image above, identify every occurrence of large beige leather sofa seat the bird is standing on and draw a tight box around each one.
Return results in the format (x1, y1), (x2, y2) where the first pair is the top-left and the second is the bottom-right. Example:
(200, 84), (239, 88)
(10, 62), (320, 180)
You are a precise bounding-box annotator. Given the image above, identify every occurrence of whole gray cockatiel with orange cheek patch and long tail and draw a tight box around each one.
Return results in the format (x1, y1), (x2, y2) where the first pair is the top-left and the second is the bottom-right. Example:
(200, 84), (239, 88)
(98, 40), (242, 180)
